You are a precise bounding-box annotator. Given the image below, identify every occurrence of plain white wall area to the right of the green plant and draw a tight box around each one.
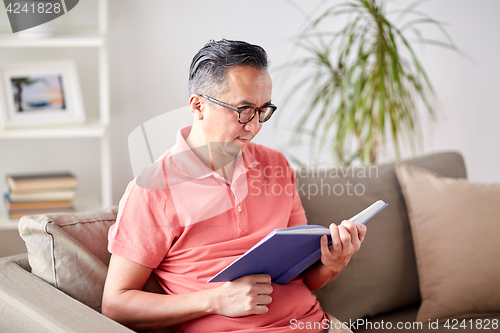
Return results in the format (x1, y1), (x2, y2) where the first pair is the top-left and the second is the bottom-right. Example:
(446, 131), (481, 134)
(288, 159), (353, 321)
(408, 0), (500, 183)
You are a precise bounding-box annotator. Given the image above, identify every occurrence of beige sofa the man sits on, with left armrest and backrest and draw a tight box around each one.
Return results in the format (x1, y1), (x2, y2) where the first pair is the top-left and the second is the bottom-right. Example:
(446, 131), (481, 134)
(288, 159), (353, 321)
(0, 152), (500, 332)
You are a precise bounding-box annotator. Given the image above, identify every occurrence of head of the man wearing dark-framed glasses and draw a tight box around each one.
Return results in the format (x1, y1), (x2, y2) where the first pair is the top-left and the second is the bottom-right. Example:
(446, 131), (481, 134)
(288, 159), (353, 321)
(188, 40), (275, 154)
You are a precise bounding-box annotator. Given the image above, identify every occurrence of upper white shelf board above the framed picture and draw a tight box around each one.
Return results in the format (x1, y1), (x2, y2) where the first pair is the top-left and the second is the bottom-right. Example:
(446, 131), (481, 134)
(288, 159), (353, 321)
(0, 28), (104, 47)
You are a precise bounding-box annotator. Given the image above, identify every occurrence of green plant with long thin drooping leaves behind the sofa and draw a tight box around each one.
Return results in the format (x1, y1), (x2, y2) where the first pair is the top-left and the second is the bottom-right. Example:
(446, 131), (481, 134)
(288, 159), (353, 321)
(284, 0), (458, 165)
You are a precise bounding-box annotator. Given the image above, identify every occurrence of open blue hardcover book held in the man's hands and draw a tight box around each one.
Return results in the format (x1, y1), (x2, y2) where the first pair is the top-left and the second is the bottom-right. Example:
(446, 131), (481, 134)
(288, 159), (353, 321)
(208, 200), (387, 284)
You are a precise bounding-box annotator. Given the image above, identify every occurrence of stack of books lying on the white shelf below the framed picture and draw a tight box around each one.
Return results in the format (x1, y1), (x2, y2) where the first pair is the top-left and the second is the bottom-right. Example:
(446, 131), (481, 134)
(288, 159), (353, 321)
(4, 172), (76, 219)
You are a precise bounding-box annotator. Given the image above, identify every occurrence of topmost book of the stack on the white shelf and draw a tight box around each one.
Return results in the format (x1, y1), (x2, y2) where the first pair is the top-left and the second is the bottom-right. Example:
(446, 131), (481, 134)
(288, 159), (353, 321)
(7, 172), (77, 191)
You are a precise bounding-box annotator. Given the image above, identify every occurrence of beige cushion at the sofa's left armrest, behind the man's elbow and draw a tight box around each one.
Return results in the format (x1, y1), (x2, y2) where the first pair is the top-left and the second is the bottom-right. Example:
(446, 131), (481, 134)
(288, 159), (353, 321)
(19, 208), (117, 312)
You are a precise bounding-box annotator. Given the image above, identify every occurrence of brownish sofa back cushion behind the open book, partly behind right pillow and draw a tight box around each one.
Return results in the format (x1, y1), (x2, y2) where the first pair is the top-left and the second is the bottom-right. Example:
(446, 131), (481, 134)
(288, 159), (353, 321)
(297, 153), (466, 320)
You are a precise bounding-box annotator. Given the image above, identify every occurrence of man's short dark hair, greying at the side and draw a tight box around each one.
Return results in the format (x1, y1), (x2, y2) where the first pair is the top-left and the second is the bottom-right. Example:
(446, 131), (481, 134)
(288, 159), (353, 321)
(188, 39), (268, 97)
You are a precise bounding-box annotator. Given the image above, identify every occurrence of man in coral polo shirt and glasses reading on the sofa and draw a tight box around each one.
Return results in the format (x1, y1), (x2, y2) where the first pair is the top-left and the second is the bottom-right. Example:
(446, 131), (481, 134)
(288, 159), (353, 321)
(102, 40), (366, 333)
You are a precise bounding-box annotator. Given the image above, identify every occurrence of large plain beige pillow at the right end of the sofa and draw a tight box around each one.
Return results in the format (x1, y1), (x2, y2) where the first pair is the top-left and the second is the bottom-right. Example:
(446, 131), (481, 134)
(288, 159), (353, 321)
(396, 163), (500, 322)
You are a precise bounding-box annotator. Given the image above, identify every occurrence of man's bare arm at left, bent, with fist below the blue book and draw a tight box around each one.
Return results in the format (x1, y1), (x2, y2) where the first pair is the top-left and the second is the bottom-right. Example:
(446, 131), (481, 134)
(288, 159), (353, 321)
(102, 255), (272, 329)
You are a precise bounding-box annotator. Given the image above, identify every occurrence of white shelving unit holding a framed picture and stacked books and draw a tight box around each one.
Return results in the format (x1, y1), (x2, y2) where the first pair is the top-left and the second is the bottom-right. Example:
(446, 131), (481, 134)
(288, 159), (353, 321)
(0, 0), (112, 230)
